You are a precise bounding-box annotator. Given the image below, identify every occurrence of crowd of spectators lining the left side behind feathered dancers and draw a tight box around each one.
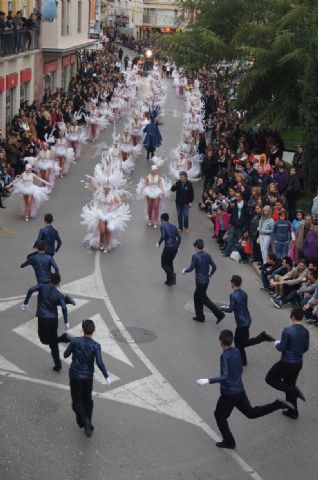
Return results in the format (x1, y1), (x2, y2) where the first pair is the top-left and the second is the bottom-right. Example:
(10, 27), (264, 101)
(0, 29), (143, 207)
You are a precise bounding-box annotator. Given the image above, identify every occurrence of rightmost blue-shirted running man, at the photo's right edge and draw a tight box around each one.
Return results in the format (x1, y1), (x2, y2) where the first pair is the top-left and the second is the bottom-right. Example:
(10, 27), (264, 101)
(265, 307), (309, 420)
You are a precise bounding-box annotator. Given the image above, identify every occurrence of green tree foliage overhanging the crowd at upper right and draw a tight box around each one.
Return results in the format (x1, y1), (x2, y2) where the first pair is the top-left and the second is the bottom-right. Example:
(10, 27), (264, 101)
(160, 0), (318, 188)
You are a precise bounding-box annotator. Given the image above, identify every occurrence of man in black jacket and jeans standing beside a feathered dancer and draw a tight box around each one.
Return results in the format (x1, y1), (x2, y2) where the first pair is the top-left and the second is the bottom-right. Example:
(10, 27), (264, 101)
(171, 171), (194, 233)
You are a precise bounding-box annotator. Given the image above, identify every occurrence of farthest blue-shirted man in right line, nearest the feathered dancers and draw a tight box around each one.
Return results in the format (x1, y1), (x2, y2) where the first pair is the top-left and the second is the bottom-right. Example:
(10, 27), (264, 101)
(157, 213), (181, 287)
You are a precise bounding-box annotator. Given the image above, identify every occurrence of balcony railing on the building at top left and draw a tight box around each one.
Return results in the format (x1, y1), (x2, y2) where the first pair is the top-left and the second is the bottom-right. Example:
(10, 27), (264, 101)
(0, 28), (40, 57)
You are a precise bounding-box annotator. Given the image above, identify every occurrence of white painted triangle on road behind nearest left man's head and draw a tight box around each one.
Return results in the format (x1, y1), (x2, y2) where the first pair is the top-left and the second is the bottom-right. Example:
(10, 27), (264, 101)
(69, 313), (134, 368)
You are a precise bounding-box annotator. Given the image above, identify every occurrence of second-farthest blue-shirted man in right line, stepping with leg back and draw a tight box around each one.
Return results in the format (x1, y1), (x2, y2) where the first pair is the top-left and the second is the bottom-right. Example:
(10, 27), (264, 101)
(182, 238), (225, 322)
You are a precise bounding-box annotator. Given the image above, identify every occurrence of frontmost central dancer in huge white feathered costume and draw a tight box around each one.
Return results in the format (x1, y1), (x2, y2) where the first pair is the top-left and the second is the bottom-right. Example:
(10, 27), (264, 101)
(81, 185), (131, 253)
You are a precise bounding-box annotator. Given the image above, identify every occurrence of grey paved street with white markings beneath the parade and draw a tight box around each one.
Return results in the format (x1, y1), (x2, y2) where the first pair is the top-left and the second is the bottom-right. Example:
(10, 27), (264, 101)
(0, 76), (318, 480)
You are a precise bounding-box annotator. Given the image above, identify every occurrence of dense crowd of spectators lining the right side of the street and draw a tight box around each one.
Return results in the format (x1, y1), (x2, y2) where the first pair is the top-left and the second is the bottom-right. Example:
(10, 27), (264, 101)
(190, 66), (318, 326)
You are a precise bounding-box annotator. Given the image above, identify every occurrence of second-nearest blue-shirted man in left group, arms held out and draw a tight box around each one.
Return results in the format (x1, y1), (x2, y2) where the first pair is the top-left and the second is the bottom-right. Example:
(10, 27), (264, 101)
(21, 273), (70, 372)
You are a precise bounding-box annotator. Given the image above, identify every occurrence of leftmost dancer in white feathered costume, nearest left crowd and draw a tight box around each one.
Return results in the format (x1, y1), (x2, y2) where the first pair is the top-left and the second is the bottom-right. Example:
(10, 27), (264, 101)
(8, 164), (51, 222)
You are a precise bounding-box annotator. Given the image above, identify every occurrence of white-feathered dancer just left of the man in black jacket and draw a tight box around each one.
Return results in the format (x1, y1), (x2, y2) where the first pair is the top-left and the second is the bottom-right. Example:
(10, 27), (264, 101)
(137, 164), (171, 228)
